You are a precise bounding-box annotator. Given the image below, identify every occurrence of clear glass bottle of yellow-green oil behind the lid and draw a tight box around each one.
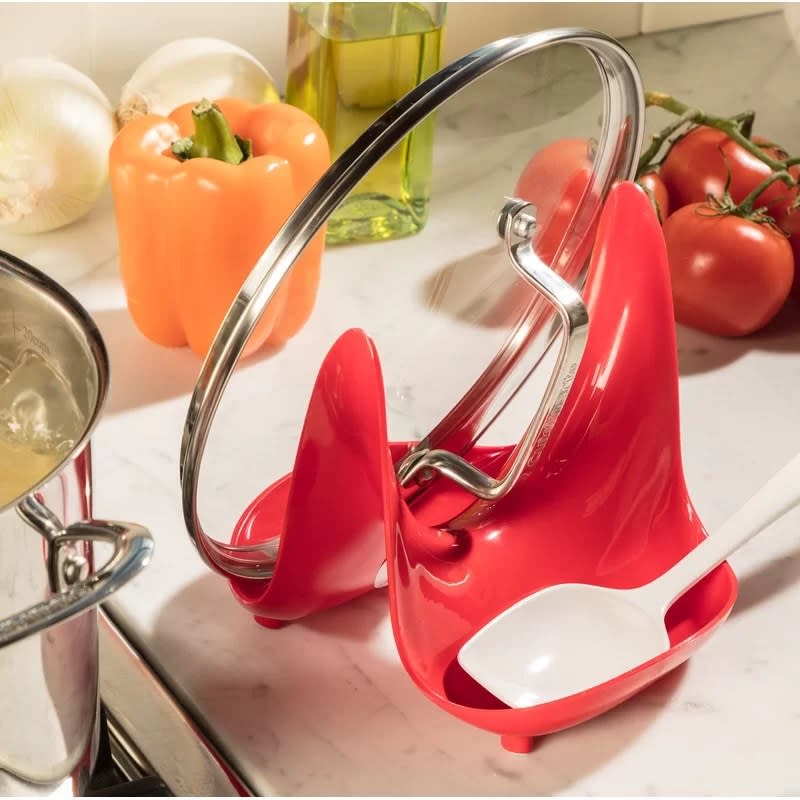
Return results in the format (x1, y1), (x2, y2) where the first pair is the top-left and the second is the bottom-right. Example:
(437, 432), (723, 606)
(286, 2), (445, 243)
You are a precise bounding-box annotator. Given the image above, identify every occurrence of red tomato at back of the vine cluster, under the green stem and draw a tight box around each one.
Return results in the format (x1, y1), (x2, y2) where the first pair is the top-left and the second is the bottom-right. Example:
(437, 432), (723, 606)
(659, 125), (800, 213)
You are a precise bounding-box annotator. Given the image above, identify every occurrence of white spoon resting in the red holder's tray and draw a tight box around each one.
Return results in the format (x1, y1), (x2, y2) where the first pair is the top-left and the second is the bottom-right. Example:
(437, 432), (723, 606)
(458, 456), (800, 708)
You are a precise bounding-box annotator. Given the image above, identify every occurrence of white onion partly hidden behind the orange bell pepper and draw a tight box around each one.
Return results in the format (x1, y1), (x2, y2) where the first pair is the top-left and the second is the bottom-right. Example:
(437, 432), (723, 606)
(117, 38), (280, 125)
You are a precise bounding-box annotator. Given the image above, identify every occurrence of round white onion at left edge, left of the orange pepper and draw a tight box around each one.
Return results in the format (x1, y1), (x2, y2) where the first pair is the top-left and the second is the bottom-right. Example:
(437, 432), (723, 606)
(0, 58), (116, 233)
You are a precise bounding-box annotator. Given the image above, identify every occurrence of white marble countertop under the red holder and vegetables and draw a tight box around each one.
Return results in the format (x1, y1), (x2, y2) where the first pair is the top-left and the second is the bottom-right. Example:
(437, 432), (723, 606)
(9, 9), (800, 795)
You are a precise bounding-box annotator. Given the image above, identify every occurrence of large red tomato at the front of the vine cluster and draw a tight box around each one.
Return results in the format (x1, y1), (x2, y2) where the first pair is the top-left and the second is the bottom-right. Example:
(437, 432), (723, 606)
(663, 203), (794, 336)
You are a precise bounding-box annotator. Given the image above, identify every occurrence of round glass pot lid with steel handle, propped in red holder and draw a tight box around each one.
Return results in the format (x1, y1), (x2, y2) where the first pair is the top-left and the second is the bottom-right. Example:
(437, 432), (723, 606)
(180, 23), (644, 578)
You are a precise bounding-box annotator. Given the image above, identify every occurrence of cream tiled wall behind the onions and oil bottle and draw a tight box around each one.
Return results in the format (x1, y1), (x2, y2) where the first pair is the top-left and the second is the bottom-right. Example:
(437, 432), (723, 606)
(0, 2), (782, 100)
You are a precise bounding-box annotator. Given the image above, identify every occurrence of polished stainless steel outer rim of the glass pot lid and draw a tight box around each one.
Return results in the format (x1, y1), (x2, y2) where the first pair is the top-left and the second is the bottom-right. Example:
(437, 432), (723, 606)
(180, 28), (644, 579)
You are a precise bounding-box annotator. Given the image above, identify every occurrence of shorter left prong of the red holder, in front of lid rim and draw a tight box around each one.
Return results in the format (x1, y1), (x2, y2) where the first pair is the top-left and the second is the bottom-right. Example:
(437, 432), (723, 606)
(231, 330), (394, 626)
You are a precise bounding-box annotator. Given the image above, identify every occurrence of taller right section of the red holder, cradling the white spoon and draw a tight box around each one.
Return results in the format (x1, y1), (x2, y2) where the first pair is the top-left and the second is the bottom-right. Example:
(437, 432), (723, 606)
(388, 184), (737, 735)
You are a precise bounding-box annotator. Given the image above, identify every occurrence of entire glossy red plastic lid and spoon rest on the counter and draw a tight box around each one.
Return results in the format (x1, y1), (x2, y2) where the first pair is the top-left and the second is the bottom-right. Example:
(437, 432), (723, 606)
(225, 183), (737, 752)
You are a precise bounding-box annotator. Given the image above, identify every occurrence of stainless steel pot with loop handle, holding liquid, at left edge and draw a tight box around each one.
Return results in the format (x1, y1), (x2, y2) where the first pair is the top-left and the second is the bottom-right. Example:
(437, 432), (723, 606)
(0, 252), (152, 795)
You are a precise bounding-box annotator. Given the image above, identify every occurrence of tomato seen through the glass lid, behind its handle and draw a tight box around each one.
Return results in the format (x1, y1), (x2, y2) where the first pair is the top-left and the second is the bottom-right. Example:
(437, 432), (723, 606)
(514, 139), (596, 271)
